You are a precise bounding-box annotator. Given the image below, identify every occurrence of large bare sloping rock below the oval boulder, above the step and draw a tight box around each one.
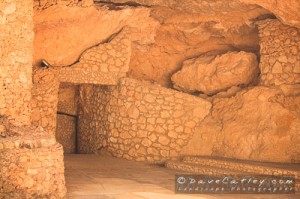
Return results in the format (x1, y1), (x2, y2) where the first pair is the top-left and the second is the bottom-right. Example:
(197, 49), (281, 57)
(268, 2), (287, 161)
(183, 85), (300, 162)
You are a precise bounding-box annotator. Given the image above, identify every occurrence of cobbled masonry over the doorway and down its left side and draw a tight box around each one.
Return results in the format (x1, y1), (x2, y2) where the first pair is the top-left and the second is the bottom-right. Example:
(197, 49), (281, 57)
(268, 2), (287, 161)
(31, 26), (131, 142)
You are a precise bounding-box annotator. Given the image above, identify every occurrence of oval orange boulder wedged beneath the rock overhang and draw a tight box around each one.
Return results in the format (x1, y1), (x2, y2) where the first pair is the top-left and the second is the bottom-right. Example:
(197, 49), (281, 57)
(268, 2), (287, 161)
(172, 52), (259, 95)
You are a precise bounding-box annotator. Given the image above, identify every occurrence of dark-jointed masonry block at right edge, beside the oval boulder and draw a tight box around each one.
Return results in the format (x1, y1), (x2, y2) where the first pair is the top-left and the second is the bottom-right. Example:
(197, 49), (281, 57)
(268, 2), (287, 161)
(258, 19), (300, 85)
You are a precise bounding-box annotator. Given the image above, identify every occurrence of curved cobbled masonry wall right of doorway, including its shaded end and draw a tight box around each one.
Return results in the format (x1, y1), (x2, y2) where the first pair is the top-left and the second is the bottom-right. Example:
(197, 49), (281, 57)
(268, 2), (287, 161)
(78, 78), (211, 162)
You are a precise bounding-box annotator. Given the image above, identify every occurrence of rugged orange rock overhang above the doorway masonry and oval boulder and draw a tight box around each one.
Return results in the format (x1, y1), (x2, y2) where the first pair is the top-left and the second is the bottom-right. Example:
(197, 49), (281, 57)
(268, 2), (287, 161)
(34, 1), (271, 87)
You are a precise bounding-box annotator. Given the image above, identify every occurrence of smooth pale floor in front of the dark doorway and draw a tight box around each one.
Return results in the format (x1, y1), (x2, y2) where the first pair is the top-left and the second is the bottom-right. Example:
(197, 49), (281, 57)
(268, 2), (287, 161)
(65, 155), (300, 199)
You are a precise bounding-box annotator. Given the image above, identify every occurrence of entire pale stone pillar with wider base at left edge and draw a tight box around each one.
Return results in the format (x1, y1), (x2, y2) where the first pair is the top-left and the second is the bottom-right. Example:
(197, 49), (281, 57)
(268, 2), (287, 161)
(0, 0), (66, 198)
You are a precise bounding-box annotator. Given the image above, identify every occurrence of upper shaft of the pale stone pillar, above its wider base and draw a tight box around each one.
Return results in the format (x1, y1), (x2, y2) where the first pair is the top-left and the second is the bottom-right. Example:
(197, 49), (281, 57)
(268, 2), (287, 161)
(0, 0), (33, 126)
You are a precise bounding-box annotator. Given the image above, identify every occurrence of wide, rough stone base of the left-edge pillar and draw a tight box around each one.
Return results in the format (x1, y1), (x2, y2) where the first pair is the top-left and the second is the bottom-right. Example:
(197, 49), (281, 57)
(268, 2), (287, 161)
(0, 128), (66, 198)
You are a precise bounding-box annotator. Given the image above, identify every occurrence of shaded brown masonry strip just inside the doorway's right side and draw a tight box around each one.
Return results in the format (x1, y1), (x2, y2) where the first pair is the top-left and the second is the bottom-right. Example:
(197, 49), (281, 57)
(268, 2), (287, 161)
(78, 85), (110, 154)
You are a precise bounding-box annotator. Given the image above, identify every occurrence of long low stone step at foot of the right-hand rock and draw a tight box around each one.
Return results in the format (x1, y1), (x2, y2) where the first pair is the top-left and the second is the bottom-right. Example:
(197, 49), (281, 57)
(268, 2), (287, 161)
(182, 156), (300, 179)
